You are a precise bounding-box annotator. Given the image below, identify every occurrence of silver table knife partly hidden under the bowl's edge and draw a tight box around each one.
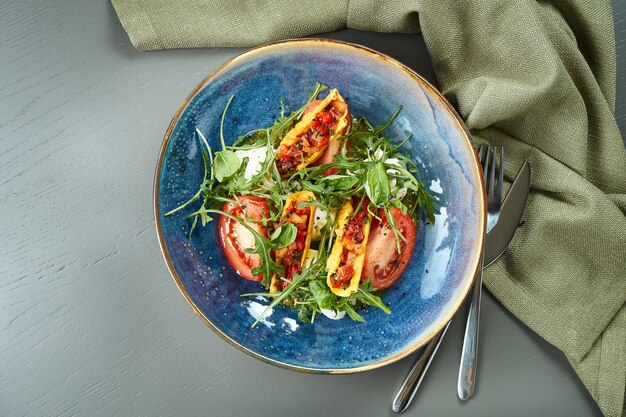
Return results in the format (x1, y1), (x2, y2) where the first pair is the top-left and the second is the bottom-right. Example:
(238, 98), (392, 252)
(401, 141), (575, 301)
(391, 160), (530, 413)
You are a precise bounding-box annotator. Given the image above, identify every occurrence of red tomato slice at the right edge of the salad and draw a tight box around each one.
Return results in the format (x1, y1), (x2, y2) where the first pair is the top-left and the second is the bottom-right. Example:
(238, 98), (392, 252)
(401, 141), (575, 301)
(361, 208), (417, 290)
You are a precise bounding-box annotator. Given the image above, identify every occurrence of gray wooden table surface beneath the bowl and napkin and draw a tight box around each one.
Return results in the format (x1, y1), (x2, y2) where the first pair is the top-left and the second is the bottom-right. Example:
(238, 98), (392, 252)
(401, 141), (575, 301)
(0, 0), (626, 417)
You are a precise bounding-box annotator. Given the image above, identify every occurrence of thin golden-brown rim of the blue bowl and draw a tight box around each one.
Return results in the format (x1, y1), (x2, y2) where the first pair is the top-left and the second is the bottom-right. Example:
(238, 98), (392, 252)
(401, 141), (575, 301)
(153, 38), (487, 374)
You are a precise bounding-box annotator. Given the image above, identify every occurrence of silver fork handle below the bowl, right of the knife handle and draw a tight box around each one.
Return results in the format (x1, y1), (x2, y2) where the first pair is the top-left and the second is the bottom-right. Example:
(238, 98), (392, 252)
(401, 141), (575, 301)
(457, 254), (484, 400)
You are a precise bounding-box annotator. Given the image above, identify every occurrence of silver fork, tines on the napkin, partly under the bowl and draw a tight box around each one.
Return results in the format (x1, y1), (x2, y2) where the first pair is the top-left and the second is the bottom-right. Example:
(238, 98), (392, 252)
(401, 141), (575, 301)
(457, 145), (504, 400)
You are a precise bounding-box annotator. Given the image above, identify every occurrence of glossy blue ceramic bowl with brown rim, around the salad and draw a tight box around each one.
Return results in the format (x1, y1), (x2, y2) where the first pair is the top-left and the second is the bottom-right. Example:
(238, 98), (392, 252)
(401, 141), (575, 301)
(154, 39), (486, 373)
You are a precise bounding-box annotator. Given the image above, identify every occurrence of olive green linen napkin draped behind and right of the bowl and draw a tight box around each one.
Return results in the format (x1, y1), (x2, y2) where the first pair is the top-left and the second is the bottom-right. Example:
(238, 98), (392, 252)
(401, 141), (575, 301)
(112, 0), (626, 417)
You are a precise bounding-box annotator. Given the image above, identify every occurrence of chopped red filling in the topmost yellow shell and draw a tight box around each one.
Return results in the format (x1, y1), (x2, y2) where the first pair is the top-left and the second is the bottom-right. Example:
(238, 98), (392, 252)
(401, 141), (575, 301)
(276, 106), (340, 175)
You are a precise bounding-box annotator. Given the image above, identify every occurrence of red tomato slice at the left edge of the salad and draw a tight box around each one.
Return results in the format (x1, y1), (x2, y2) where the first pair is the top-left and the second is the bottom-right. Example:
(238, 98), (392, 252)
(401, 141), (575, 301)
(218, 196), (270, 281)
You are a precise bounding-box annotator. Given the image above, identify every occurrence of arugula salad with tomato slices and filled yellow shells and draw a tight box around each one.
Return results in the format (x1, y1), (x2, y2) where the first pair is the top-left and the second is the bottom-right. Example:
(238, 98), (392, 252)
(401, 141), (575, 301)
(165, 83), (438, 325)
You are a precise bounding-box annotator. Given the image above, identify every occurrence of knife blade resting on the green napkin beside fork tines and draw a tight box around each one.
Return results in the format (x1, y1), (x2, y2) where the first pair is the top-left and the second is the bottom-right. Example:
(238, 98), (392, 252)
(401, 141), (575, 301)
(484, 160), (530, 267)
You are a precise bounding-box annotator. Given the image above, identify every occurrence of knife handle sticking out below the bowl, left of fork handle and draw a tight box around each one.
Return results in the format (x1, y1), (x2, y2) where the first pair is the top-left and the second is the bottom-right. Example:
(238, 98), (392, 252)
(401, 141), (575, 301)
(391, 322), (450, 414)
